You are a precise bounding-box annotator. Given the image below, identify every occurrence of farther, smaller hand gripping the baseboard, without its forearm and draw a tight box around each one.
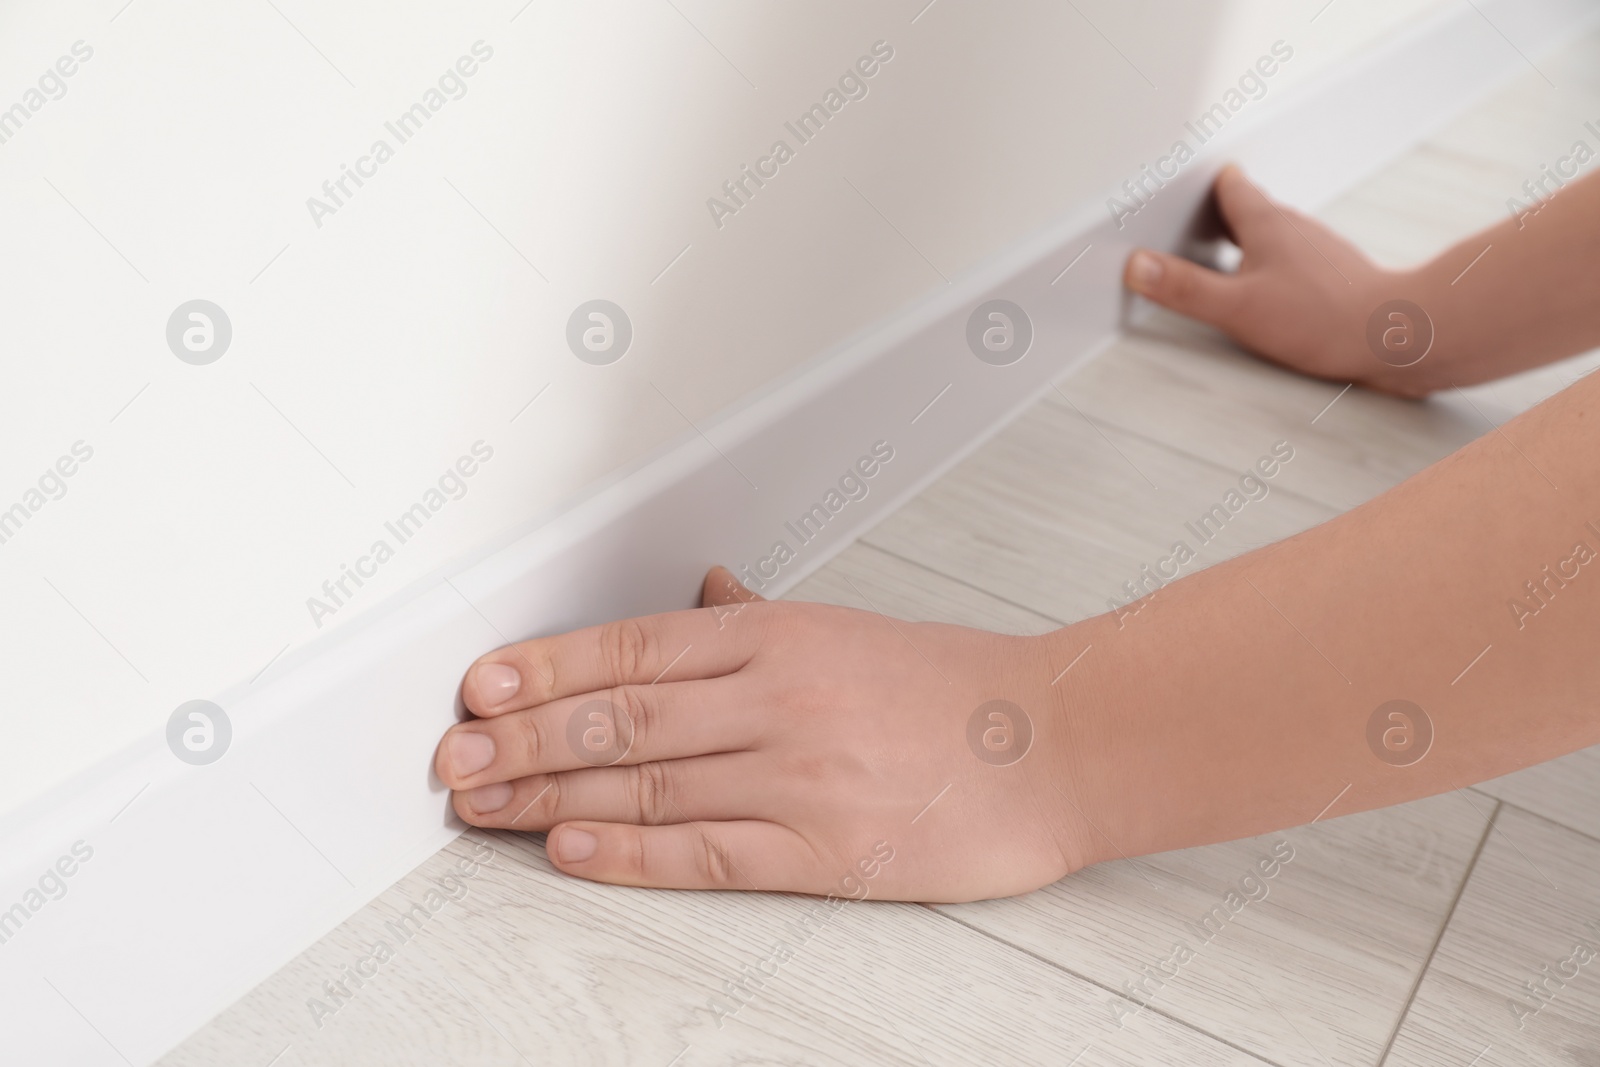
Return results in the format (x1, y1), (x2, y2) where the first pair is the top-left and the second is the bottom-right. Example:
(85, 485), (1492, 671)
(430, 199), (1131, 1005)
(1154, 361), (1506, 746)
(1123, 166), (1440, 397)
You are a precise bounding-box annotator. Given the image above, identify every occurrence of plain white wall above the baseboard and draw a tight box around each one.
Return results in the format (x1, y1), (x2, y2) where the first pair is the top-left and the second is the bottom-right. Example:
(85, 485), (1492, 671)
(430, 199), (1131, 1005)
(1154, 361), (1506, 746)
(0, 0), (1459, 811)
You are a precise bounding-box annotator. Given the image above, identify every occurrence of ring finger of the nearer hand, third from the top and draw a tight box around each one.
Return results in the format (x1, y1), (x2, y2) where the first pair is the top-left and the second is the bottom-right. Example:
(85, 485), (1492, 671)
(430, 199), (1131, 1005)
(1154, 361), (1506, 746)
(451, 752), (765, 830)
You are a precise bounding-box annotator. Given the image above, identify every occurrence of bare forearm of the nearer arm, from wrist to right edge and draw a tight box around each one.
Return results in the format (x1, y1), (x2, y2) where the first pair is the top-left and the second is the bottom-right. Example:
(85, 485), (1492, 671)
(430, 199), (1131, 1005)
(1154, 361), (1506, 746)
(1045, 371), (1600, 859)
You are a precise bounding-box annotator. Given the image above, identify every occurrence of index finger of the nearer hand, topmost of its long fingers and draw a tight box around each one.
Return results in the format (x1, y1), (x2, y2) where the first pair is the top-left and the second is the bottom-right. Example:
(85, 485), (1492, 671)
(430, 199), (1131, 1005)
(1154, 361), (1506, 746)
(461, 608), (760, 715)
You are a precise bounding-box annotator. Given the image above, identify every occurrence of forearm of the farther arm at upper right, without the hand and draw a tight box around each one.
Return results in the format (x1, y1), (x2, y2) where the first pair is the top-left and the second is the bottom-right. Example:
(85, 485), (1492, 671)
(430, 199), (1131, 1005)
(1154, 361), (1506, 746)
(1392, 163), (1600, 390)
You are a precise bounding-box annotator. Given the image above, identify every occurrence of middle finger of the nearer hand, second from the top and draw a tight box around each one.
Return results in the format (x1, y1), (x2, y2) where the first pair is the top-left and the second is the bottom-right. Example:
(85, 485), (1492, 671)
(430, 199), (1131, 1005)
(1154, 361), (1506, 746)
(434, 678), (763, 789)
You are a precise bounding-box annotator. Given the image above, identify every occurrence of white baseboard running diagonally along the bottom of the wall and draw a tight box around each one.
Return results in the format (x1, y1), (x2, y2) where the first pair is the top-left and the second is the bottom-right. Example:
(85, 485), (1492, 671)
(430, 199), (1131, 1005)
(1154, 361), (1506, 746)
(0, 0), (1600, 1064)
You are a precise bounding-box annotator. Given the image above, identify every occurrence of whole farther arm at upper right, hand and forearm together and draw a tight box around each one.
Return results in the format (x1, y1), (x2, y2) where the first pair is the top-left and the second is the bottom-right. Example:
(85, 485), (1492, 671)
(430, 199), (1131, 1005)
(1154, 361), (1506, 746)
(1125, 158), (1600, 391)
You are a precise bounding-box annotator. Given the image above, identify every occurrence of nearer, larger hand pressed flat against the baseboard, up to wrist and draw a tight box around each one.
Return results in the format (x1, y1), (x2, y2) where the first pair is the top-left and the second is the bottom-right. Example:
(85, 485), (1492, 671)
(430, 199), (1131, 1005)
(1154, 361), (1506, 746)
(435, 568), (1098, 901)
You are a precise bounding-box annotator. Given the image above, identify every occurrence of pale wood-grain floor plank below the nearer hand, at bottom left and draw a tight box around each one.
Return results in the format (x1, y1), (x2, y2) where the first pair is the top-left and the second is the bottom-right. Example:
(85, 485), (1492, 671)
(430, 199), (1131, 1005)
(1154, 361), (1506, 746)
(162, 832), (1259, 1067)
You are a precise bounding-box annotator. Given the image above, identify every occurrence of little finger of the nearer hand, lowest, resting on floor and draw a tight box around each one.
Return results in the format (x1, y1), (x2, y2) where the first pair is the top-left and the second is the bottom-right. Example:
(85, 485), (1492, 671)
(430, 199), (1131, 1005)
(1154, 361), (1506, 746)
(546, 819), (822, 893)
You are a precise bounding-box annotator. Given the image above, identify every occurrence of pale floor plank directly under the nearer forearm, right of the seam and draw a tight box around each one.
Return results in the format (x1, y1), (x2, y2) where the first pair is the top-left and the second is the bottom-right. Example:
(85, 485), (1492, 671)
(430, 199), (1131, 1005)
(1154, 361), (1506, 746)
(941, 784), (1491, 1064)
